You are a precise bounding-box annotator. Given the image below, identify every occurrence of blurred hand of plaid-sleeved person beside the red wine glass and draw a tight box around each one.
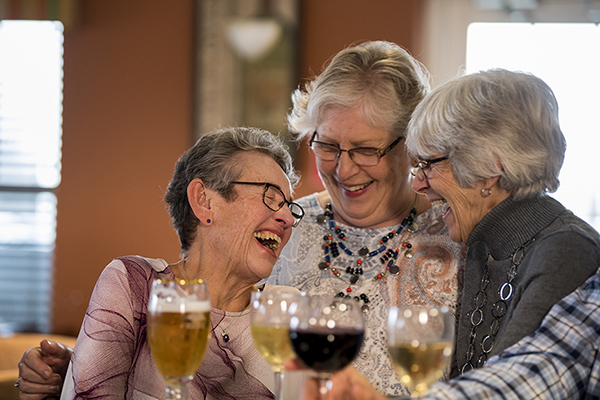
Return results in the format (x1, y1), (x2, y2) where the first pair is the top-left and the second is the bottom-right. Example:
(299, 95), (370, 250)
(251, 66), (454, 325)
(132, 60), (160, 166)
(285, 360), (388, 400)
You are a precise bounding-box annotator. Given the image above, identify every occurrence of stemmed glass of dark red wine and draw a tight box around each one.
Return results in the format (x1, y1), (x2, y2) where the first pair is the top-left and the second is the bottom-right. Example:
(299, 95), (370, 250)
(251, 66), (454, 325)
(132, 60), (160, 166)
(290, 296), (365, 399)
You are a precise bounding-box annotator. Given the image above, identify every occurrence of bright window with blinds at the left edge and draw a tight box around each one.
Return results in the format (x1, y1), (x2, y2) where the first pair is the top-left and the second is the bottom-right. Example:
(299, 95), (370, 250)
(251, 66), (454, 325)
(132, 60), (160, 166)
(0, 20), (63, 332)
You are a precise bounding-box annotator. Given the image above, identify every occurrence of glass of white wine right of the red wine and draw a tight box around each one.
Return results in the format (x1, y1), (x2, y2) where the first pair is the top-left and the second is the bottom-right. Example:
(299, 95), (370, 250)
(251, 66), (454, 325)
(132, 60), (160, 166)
(388, 306), (455, 397)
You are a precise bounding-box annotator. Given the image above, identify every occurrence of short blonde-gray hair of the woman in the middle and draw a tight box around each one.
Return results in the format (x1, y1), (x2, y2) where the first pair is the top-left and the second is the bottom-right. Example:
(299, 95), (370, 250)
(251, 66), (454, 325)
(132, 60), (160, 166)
(288, 41), (430, 141)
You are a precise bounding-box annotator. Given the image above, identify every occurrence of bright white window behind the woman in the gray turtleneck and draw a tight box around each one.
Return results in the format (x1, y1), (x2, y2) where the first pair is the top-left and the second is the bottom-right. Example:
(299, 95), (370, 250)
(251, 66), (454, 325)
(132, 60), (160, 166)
(466, 23), (600, 230)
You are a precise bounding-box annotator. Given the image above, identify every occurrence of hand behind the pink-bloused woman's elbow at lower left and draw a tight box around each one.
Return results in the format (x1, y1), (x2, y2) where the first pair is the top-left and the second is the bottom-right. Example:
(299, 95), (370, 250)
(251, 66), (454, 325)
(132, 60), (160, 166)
(18, 340), (73, 400)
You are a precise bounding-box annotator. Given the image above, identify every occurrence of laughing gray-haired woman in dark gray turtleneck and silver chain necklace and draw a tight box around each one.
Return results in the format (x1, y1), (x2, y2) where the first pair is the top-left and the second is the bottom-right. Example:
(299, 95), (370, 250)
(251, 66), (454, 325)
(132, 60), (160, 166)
(406, 69), (600, 376)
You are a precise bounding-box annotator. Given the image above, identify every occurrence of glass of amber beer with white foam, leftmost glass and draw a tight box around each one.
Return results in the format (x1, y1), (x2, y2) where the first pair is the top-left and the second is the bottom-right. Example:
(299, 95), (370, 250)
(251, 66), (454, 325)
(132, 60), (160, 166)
(148, 279), (210, 400)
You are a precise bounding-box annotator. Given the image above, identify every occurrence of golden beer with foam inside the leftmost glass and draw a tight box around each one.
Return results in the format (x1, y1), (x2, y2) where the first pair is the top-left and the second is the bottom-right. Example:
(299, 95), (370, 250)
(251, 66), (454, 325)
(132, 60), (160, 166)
(148, 302), (210, 382)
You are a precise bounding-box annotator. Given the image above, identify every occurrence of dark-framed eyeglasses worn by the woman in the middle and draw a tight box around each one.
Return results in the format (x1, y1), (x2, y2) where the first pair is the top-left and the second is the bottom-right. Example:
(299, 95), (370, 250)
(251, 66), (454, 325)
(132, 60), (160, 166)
(309, 131), (404, 167)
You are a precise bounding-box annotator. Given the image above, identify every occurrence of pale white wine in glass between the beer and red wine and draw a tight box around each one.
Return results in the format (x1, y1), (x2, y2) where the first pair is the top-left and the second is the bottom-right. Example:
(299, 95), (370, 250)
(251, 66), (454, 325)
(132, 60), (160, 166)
(250, 325), (295, 372)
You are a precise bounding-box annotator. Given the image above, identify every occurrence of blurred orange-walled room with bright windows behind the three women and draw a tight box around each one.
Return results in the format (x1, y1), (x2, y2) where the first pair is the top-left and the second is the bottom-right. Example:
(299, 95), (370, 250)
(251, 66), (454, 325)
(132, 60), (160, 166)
(0, 0), (600, 336)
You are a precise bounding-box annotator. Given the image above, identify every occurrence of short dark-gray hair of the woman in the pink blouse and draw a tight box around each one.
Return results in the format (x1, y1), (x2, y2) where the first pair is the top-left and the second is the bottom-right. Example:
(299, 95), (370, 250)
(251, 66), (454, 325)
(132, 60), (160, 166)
(165, 127), (299, 251)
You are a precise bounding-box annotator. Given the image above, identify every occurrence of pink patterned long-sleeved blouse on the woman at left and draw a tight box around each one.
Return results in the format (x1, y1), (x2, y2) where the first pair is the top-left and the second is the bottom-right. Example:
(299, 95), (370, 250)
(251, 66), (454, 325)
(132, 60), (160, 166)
(61, 256), (301, 400)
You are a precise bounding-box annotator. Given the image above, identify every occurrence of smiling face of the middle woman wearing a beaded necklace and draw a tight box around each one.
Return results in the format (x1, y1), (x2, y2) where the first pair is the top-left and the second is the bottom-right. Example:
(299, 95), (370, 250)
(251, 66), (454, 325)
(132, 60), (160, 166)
(315, 108), (414, 228)
